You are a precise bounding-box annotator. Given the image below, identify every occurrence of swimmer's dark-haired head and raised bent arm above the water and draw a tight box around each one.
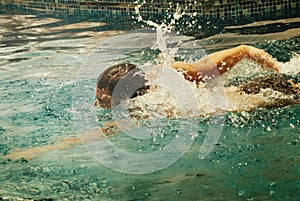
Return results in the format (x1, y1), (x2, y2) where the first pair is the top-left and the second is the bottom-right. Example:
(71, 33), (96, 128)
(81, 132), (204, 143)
(95, 45), (279, 109)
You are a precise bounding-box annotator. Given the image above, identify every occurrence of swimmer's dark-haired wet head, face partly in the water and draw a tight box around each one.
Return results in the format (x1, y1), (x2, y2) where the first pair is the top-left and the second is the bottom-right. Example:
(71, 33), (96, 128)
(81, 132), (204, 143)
(95, 63), (149, 109)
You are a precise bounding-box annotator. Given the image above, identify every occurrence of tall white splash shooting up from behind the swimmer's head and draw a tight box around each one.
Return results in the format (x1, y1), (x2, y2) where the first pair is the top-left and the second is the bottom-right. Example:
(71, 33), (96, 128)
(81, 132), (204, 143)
(129, 1), (206, 117)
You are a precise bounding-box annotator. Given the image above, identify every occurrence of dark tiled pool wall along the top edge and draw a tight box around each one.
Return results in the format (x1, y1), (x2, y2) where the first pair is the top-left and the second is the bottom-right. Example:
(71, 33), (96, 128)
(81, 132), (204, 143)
(0, 0), (300, 20)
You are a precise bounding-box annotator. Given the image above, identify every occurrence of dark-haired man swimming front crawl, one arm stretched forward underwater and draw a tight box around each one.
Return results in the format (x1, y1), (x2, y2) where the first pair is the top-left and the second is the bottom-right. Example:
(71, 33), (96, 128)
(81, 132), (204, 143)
(4, 45), (300, 160)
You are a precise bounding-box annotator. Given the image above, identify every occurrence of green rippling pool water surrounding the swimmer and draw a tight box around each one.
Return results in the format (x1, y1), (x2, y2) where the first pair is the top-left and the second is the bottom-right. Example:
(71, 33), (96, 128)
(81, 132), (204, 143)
(0, 11), (300, 200)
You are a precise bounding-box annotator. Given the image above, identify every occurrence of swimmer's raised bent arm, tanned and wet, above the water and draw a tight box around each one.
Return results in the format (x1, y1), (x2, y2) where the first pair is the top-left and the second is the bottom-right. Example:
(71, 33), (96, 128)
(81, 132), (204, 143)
(172, 45), (279, 81)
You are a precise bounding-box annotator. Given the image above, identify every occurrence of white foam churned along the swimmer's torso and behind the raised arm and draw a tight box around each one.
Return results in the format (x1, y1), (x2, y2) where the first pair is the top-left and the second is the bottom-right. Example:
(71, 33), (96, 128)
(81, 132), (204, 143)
(129, 55), (300, 118)
